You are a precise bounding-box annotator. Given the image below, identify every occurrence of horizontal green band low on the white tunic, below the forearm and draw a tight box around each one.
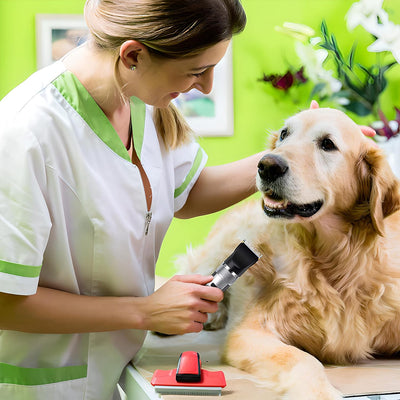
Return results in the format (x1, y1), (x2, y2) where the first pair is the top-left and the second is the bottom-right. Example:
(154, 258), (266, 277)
(0, 363), (87, 386)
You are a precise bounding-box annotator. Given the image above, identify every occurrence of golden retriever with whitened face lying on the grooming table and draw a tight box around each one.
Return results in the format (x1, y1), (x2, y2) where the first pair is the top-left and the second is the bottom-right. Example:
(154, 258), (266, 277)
(179, 109), (400, 400)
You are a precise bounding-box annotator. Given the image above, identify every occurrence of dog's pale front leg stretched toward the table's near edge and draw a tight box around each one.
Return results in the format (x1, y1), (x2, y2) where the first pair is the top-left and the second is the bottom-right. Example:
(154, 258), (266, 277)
(224, 315), (342, 400)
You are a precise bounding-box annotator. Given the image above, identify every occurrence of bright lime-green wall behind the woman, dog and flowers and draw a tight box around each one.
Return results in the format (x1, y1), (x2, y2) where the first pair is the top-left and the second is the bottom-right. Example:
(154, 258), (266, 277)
(0, 0), (400, 276)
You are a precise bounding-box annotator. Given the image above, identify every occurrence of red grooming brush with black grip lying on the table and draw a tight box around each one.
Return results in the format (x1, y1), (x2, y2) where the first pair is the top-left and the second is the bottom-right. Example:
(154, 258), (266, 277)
(151, 351), (226, 396)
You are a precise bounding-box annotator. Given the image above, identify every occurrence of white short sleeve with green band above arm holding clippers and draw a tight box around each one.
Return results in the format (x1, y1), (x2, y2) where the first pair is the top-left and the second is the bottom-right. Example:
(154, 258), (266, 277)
(0, 122), (51, 295)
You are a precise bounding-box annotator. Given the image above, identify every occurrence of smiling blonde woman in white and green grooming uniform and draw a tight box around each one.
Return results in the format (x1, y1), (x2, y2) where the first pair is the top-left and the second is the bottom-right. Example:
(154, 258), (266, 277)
(0, 0), (260, 400)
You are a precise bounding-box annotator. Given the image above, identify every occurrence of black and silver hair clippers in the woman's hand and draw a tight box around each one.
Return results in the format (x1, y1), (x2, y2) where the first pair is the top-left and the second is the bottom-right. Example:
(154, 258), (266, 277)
(207, 242), (260, 291)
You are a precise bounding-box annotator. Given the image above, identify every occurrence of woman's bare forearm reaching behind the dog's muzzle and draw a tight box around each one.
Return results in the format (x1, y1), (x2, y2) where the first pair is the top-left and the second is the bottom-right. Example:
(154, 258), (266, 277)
(175, 152), (264, 218)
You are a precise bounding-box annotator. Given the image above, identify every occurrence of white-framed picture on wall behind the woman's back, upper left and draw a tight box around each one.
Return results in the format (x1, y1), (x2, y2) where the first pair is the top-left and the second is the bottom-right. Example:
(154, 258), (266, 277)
(36, 14), (88, 69)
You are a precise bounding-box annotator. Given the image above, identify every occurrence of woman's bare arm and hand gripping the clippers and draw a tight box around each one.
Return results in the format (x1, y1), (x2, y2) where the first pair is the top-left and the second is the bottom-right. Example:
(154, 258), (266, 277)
(0, 275), (223, 334)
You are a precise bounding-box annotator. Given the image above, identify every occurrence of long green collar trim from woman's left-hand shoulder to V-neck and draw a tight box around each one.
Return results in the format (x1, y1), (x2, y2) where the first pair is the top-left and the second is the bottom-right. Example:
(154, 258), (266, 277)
(53, 71), (131, 161)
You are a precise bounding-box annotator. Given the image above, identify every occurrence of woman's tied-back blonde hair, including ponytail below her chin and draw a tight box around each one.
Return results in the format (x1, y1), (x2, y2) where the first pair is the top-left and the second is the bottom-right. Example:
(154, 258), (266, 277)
(85, 0), (246, 148)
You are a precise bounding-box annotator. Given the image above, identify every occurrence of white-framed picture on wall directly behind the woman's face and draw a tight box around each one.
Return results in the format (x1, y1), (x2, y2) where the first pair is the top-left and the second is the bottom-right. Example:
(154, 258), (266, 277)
(174, 45), (233, 136)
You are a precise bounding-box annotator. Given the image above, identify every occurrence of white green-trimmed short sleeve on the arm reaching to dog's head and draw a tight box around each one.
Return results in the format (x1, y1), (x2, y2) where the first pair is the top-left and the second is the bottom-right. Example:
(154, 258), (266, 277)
(174, 141), (207, 212)
